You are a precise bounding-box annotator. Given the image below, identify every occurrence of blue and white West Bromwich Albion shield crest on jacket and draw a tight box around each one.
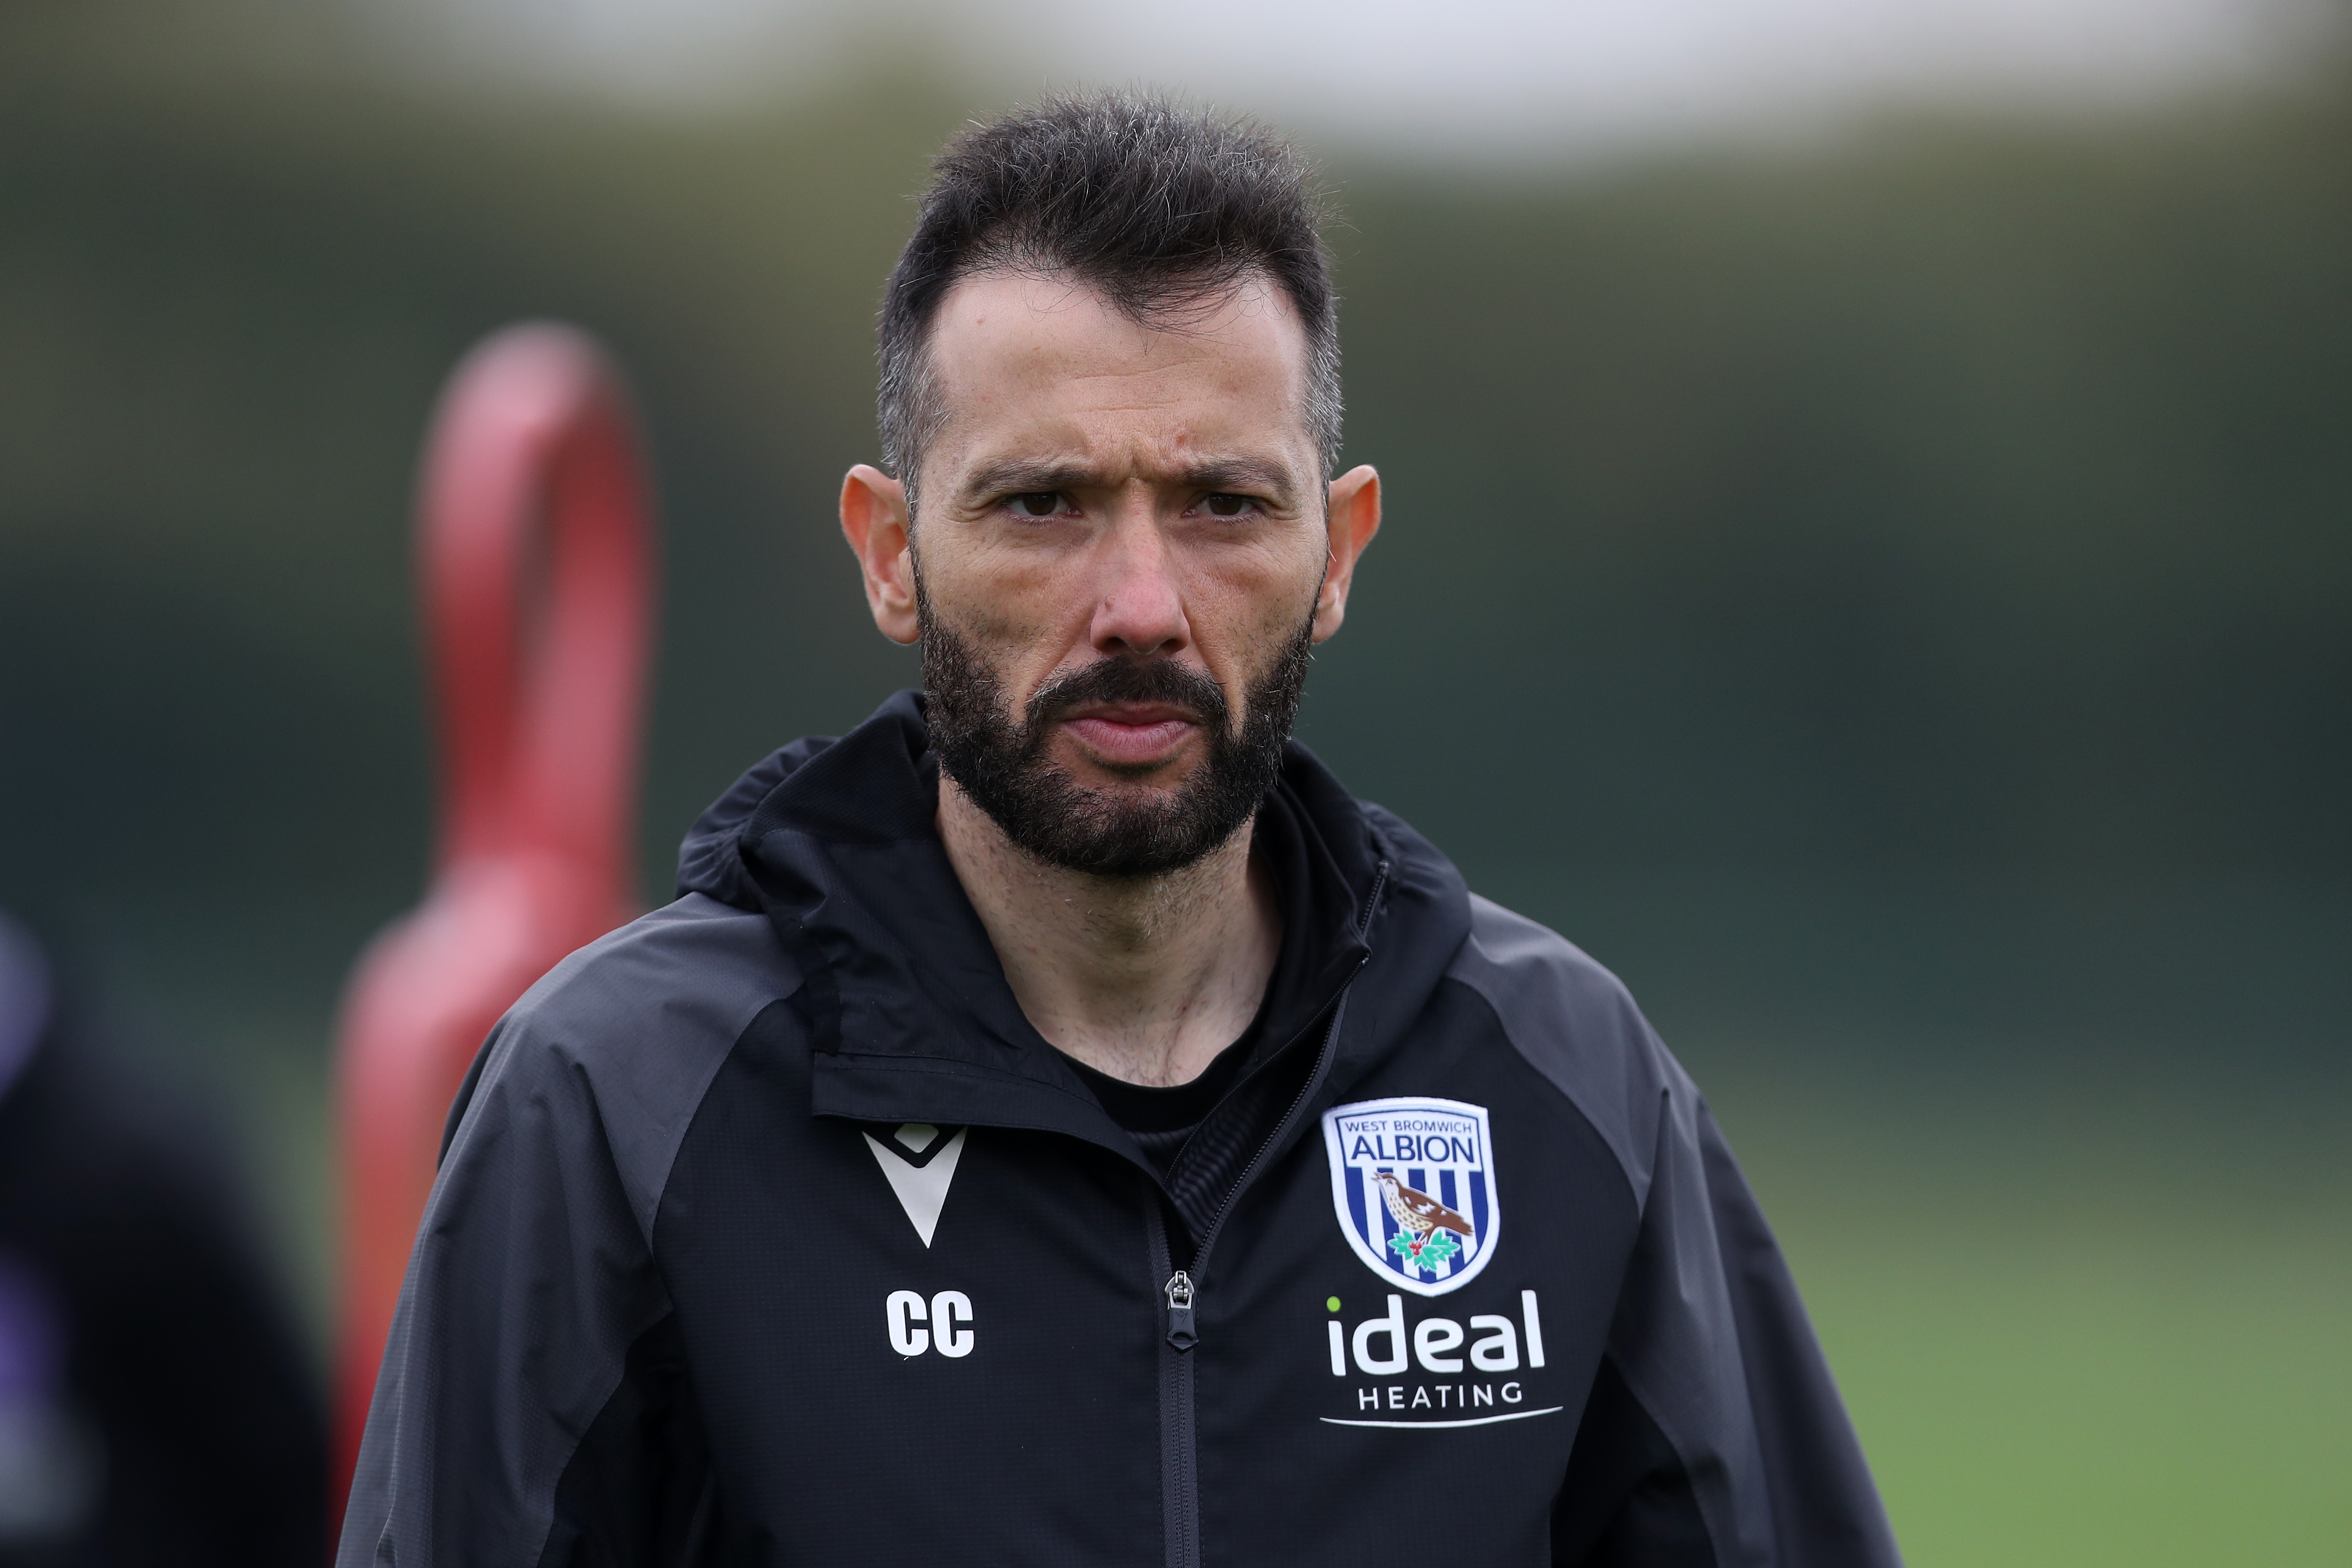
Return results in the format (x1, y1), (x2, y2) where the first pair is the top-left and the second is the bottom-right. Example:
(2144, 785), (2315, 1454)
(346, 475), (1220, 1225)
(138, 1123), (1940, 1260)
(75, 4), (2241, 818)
(1324, 1098), (1503, 1295)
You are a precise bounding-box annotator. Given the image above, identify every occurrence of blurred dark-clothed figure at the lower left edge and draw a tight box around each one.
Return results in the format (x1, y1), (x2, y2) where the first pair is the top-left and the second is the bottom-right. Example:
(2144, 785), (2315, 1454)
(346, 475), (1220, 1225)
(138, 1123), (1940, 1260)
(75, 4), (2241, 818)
(0, 917), (327, 1568)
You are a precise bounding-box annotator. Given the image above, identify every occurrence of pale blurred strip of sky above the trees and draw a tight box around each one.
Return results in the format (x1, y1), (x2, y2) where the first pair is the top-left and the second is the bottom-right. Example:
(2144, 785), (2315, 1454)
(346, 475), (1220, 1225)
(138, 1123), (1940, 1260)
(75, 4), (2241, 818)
(376, 0), (2342, 160)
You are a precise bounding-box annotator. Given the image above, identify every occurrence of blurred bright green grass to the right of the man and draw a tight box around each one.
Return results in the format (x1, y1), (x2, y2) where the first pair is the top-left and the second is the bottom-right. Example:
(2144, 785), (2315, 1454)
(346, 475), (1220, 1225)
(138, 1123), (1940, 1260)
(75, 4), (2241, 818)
(1712, 1062), (2352, 1568)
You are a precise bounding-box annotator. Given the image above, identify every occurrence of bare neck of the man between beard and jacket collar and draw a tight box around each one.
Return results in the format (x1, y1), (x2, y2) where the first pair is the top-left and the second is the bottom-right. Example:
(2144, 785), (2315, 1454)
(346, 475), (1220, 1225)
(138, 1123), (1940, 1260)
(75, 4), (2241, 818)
(938, 776), (1282, 1086)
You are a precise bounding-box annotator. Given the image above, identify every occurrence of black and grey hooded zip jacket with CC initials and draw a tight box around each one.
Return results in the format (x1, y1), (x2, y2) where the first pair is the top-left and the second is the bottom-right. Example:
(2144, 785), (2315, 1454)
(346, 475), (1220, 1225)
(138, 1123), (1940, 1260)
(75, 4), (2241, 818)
(341, 693), (1898, 1568)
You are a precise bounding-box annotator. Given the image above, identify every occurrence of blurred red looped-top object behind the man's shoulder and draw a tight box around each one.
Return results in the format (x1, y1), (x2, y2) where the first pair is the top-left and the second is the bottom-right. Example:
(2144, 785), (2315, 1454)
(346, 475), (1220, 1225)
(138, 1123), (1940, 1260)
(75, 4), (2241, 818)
(334, 325), (654, 1518)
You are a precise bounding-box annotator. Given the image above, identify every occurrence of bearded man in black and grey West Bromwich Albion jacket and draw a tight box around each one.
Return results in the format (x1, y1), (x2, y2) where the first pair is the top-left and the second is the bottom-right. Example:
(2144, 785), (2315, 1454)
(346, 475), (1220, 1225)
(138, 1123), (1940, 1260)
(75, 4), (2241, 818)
(344, 96), (1896, 1568)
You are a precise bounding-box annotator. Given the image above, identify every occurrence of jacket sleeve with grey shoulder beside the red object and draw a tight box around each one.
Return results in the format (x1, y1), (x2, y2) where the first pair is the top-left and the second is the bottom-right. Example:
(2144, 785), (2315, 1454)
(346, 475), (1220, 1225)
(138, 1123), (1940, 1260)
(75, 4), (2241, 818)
(336, 896), (797, 1568)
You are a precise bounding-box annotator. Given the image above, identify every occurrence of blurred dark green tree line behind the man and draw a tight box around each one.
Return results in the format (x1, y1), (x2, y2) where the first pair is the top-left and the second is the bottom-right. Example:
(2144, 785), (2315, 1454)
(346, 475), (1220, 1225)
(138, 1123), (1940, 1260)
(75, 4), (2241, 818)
(0, 0), (2352, 1062)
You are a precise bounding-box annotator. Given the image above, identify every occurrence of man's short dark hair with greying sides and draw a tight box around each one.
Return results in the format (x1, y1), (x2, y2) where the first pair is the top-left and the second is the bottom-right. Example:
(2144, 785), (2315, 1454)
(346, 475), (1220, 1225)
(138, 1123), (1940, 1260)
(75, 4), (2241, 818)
(875, 92), (1341, 505)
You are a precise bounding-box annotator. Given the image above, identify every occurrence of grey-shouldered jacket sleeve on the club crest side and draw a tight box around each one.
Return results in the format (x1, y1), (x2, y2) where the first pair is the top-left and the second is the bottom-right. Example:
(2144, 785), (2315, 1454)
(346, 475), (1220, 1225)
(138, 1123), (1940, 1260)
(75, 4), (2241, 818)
(1449, 896), (1900, 1568)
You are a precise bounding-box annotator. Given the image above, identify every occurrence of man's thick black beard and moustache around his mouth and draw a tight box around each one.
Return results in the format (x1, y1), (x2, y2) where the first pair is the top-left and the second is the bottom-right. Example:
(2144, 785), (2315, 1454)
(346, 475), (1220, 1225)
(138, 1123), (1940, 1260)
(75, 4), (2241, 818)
(915, 592), (1315, 877)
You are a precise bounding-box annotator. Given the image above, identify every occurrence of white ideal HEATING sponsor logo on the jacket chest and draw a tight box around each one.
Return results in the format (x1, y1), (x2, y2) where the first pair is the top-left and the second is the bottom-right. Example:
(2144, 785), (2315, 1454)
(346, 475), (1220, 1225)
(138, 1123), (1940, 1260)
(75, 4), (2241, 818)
(1322, 1291), (1562, 1427)
